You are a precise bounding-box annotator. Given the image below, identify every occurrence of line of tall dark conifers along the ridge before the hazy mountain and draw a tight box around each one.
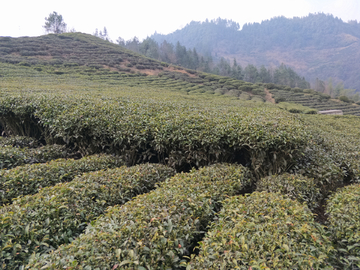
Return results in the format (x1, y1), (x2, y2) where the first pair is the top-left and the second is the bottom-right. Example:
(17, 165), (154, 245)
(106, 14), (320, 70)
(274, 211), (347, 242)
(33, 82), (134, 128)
(114, 36), (310, 89)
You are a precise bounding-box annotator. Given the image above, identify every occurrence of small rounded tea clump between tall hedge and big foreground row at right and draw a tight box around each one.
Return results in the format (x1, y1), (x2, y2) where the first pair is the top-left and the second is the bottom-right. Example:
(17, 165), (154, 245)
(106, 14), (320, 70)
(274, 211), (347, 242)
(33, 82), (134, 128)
(256, 173), (323, 210)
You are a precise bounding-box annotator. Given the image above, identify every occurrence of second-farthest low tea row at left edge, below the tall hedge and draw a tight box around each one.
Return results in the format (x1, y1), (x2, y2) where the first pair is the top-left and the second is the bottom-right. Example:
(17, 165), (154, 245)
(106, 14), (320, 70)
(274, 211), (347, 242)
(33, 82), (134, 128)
(0, 144), (67, 169)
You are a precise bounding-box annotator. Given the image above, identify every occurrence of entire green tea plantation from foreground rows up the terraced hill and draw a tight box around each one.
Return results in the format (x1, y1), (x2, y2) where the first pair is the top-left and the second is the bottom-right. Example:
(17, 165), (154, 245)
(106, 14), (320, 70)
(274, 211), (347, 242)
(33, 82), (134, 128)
(0, 33), (360, 270)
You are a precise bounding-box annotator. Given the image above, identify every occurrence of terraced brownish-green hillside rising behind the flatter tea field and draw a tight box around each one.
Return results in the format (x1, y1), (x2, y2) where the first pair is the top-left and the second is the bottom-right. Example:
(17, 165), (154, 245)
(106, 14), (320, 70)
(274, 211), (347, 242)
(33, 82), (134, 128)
(0, 33), (360, 116)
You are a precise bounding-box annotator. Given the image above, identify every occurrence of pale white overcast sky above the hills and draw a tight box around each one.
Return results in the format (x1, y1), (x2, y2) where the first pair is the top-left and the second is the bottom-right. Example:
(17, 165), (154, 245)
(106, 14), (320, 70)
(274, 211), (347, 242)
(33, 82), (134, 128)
(0, 0), (360, 41)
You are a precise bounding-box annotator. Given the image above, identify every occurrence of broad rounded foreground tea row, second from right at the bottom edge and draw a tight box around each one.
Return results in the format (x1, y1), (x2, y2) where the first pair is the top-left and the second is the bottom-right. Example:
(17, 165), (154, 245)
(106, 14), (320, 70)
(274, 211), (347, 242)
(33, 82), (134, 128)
(187, 192), (333, 270)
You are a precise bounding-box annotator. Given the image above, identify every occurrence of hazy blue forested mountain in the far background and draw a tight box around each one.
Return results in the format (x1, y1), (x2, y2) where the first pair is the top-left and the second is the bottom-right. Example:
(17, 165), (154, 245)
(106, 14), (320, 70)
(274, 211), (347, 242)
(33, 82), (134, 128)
(151, 13), (360, 91)
